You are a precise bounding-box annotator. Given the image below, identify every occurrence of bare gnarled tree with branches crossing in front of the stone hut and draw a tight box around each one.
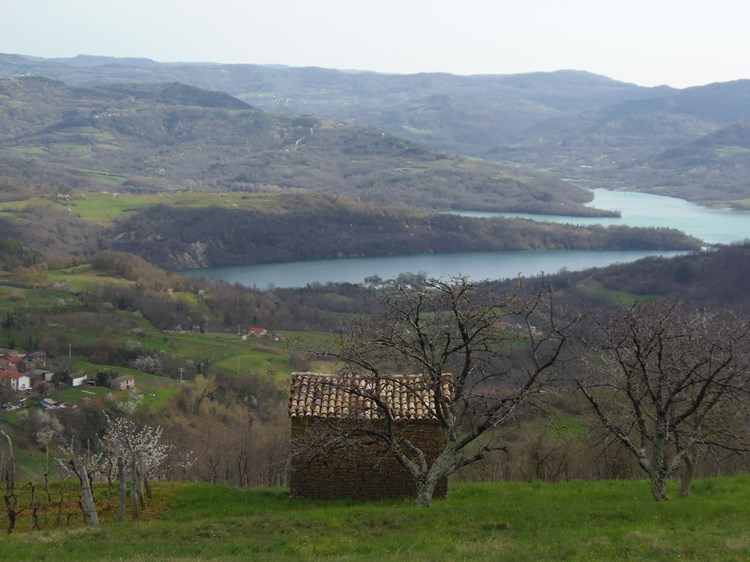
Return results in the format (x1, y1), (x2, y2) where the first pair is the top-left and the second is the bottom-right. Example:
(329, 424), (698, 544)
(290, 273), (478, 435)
(312, 277), (576, 506)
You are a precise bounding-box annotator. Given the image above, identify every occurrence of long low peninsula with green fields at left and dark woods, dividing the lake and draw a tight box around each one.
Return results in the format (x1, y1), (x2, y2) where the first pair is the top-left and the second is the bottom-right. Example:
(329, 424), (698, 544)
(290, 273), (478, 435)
(0, 189), (700, 269)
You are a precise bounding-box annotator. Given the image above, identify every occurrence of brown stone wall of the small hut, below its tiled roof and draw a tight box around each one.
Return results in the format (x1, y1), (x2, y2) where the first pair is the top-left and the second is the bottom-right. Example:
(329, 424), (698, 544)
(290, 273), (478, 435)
(289, 417), (448, 499)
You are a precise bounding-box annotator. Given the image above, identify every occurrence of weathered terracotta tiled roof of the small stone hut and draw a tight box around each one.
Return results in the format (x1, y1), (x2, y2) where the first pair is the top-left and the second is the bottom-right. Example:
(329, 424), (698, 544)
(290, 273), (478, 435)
(289, 373), (451, 420)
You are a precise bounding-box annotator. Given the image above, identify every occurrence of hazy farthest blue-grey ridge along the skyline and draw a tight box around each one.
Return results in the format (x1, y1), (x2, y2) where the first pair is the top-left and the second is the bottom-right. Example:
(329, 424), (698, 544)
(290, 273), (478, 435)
(0, 55), (670, 155)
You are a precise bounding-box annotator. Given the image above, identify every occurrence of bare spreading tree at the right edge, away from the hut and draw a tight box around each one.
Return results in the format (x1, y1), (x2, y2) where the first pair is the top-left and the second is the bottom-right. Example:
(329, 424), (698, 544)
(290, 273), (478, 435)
(578, 300), (750, 501)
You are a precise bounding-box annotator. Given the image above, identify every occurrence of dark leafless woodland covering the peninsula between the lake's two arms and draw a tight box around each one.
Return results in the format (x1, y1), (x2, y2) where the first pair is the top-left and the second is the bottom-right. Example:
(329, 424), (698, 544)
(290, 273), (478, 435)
(102, 197), (700, 269)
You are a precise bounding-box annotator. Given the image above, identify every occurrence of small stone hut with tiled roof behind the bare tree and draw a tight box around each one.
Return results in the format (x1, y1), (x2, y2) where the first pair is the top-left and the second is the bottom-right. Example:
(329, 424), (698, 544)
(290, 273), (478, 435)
(289, 373), (450, 499)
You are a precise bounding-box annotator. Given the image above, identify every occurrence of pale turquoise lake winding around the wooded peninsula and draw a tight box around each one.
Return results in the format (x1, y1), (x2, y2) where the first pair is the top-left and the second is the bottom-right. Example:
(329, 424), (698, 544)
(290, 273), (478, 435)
(182, 189), (750, 289)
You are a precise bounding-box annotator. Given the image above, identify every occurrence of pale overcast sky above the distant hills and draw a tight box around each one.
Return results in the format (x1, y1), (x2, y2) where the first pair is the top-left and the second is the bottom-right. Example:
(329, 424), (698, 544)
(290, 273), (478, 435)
(0, 0), (750, 87)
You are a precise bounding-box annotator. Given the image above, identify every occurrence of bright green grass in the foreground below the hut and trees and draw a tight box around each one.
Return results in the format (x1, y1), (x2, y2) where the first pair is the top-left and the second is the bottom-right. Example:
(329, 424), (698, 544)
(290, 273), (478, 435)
(0, 476), (750, 561)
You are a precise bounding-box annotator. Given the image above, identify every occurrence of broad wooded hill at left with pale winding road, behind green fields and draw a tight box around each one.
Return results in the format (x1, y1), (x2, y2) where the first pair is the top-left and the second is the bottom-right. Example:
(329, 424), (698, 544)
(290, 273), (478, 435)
(0, 77), (596, 214)
